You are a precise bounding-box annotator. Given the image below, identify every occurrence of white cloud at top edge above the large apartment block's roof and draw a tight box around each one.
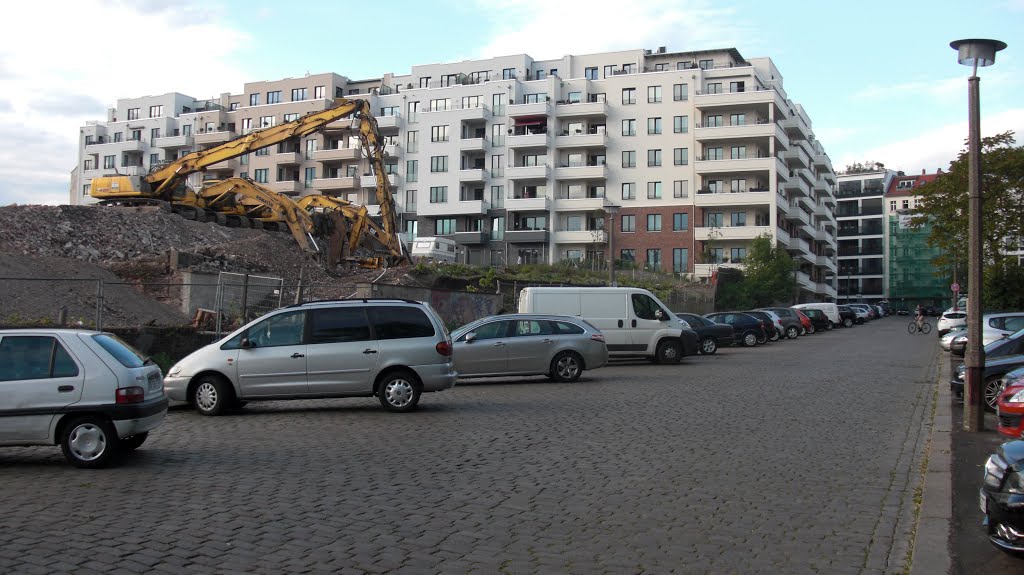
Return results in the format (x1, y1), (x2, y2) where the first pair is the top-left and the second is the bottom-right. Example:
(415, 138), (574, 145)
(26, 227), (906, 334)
(468, 0), (756, 59)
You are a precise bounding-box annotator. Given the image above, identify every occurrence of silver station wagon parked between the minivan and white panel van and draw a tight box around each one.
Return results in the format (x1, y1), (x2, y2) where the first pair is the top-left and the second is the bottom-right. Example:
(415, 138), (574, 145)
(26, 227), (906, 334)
(452, 313), (608, 382)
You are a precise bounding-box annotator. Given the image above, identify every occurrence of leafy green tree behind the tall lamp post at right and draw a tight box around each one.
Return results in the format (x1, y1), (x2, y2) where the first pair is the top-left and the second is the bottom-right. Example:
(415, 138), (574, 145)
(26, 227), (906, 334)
(911, 132), (1024, 309)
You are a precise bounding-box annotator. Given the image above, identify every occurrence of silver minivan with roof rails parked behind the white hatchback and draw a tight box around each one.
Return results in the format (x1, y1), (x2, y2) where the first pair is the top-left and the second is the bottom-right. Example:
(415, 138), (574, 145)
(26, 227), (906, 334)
(165, 299), (457, 415)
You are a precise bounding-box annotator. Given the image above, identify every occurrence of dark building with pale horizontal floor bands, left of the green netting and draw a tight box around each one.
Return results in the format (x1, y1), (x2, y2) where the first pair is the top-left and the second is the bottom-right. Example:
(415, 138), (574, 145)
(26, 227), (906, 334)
(836, 170), (897, 303)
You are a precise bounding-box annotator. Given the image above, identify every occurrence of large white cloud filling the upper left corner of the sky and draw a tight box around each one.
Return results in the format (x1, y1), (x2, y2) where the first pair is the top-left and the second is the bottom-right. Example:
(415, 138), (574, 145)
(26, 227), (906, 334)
(0, 0), (248, 205)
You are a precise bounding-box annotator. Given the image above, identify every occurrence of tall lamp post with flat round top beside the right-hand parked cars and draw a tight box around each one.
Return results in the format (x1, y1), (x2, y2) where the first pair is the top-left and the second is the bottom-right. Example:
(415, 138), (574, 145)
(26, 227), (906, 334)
(949, 39), (1007, 432)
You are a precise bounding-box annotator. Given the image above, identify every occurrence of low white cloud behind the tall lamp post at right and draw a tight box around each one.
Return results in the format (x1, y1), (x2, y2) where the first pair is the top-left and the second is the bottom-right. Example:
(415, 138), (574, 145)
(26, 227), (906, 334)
(834, 108), (1024, 174)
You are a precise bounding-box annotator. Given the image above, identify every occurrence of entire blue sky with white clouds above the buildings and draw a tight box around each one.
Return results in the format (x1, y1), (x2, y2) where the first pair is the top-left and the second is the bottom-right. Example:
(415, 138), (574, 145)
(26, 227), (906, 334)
(0, 0), (1024, 205)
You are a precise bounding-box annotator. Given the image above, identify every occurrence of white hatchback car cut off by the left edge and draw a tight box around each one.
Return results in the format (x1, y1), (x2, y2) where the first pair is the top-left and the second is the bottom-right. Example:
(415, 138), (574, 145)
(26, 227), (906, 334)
(0, 329), (167, 468)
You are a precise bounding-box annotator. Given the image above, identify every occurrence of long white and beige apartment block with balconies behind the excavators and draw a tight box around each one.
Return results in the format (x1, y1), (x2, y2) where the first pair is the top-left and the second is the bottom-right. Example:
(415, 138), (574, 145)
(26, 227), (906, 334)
(72, 48), (837, 300)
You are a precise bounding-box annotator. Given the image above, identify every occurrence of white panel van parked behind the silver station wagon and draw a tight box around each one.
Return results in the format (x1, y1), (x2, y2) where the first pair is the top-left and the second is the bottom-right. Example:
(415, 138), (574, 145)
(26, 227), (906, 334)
(519, 288), (697, 363)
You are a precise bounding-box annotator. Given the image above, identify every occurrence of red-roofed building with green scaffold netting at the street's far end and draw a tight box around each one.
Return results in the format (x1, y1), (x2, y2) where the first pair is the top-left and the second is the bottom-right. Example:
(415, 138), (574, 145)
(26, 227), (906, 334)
(884, 172), (946, 309)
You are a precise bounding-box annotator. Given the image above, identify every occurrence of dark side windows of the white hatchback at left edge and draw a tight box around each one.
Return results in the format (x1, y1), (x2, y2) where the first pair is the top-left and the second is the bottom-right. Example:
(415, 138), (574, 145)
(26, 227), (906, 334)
(0, 336), (78, 382)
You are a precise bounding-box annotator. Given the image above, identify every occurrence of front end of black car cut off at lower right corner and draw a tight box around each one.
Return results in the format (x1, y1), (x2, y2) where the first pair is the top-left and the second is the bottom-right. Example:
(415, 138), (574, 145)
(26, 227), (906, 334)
(979, 440), (1024, 556)
